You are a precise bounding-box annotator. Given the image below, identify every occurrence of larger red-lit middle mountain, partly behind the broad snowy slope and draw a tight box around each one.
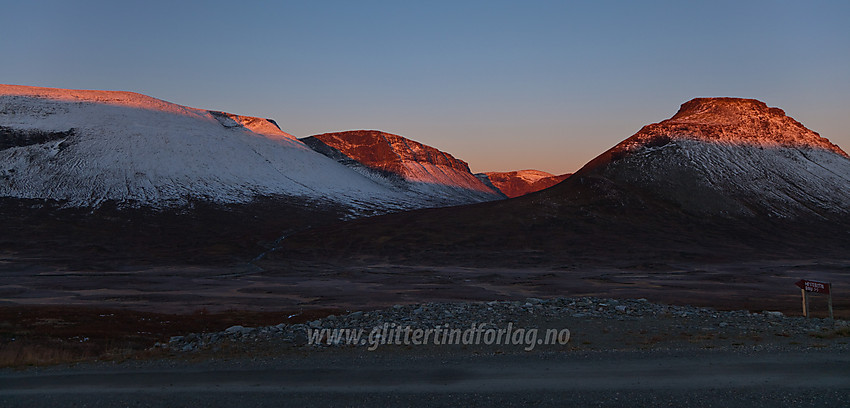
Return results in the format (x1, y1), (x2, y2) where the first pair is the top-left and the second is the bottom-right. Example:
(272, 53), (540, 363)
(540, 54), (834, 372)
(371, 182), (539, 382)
(301, 130), (504, 206)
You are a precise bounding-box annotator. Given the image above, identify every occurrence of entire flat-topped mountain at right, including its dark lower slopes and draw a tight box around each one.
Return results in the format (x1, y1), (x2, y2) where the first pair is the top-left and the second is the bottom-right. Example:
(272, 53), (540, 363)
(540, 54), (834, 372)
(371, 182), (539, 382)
(278, 98), (850, 266)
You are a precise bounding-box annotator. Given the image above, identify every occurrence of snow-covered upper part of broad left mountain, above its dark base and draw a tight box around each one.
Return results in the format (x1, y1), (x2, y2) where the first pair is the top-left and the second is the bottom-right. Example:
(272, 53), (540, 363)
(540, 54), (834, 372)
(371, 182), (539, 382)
(0, 85), (422, 209)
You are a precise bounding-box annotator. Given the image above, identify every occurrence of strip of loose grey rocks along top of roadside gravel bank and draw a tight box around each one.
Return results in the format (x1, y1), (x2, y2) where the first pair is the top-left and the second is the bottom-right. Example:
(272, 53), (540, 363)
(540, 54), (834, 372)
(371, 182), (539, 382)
(155, 297), (849, 353)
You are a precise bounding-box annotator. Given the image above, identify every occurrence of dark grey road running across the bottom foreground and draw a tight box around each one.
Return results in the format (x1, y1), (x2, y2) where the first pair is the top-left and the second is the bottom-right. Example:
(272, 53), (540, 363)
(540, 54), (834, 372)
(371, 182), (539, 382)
(0, 350), (850, 408)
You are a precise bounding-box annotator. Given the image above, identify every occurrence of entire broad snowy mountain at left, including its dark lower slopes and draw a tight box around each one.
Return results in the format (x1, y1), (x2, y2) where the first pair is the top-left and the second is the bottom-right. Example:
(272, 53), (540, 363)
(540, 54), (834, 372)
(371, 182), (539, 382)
(0, 85), (488, 267)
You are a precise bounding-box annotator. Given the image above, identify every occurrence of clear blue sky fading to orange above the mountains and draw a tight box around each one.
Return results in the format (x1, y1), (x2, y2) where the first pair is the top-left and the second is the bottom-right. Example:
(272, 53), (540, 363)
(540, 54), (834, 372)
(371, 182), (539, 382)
(0, 0), (850, 173)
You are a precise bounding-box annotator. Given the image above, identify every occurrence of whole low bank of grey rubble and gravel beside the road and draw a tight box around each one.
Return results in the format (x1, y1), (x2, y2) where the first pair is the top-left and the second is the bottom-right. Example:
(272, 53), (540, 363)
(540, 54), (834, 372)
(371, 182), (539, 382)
(162, 297), (850, 357)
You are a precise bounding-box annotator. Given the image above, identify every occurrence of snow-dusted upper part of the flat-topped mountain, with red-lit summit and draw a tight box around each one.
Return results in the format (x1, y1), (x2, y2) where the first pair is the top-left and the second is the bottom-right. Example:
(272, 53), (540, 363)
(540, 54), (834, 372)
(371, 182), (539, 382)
(574, 98), (850, 217)
